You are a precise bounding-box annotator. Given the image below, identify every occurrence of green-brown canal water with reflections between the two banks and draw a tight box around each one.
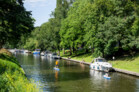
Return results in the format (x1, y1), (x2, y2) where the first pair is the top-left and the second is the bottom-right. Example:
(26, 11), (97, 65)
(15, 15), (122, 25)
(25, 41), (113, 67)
(15, 54), (139, 92)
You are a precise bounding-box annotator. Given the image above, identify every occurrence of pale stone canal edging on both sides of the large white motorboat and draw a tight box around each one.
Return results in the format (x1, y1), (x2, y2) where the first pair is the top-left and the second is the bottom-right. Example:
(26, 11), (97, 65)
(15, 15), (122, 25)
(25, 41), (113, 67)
(62, 57), (139, 77)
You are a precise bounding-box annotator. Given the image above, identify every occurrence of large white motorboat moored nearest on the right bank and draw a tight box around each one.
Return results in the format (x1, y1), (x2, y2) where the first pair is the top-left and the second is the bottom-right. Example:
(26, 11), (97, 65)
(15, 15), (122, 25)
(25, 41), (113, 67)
(90, 57), (112, 72)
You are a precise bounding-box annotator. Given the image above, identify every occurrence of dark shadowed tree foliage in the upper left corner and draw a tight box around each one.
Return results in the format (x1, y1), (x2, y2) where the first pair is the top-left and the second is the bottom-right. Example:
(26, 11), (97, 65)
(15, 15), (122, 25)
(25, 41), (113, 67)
(0, 0), (34, 48)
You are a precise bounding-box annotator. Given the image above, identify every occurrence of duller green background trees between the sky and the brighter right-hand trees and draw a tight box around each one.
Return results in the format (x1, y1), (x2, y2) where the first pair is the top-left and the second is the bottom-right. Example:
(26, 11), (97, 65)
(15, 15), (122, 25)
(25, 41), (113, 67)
(24, 0), (72, 51)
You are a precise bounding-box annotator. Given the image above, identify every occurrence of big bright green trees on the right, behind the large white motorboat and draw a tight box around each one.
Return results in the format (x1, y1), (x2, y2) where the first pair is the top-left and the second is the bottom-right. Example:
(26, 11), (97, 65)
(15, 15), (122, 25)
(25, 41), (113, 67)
(60, 0), (139, 57)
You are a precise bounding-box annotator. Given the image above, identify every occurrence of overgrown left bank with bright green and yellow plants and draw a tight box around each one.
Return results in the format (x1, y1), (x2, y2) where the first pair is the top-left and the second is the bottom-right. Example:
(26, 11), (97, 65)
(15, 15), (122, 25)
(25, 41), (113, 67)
(0, 49), (39, 92)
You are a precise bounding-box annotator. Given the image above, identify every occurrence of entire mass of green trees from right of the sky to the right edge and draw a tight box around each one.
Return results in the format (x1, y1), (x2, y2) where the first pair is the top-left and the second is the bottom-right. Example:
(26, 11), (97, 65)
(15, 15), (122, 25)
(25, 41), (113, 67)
(24, 0), (139, 57)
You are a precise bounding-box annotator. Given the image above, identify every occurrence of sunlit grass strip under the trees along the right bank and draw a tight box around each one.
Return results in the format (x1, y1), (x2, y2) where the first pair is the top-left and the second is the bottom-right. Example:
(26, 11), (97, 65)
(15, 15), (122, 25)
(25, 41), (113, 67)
(61, 51), (139, 73)
